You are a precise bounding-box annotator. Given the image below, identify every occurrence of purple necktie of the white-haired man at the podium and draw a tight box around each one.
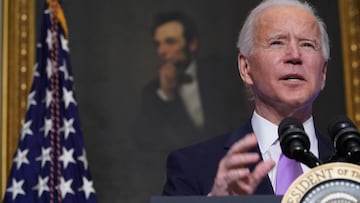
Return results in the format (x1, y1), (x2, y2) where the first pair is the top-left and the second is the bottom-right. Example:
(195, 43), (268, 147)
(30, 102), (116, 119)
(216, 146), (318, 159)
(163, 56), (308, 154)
(275, 153), (303, 195)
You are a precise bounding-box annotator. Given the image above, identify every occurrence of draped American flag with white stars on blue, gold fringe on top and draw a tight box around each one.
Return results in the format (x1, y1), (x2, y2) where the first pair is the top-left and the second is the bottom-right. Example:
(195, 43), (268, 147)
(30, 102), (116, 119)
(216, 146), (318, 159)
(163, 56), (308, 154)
(4, 0), (96, 203)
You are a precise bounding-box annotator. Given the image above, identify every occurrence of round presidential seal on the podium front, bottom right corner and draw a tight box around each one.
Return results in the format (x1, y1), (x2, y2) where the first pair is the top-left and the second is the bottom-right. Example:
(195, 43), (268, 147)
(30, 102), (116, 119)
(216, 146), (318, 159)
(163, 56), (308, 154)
(281, 162), (360, 203)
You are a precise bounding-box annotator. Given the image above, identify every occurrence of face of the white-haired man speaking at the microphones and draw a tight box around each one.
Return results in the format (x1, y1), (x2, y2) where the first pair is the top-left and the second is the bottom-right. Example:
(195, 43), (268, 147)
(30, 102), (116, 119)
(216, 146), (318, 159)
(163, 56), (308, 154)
(239, 6), (327, 114)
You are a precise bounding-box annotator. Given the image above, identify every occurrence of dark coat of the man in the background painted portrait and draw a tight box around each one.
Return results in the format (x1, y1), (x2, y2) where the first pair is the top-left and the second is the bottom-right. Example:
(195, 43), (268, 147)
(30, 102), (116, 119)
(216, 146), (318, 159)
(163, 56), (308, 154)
(134, 58), (251, 148)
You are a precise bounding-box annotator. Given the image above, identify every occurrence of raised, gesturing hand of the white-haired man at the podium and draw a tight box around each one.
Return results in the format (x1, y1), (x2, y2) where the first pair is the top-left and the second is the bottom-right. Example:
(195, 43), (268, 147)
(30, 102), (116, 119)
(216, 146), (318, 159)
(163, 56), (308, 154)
(210, 133), (275, 196)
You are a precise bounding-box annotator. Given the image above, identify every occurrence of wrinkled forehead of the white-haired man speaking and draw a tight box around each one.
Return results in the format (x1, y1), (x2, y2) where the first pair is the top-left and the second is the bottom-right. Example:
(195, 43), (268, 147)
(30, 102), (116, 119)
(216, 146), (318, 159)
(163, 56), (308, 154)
(254, 6), (320, 43)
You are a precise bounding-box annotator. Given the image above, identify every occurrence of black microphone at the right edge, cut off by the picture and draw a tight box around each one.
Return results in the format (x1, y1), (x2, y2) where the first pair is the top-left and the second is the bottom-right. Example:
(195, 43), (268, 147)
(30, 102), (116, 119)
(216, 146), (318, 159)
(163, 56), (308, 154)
(328, 115), (360, 163)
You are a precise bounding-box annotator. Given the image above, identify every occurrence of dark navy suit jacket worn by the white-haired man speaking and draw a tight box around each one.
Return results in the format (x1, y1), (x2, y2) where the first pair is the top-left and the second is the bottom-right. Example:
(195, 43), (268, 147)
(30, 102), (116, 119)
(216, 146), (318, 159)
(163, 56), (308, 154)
(163, 121), (334, 195)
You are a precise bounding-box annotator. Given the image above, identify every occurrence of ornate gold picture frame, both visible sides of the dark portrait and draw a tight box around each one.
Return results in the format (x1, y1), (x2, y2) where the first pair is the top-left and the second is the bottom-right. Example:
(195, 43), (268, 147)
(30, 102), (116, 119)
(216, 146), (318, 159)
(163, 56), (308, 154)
(0, 0), (360, 198)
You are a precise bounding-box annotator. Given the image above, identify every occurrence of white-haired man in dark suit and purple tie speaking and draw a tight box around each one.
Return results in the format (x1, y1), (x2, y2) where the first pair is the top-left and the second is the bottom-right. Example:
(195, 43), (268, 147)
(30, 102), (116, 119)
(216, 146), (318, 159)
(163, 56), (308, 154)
(163, 0), (333, 196)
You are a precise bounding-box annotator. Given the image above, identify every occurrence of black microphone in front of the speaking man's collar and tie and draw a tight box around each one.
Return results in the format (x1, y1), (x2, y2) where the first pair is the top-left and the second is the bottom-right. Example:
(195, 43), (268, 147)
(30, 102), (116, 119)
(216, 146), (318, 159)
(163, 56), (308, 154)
(278, 117), (321, 168)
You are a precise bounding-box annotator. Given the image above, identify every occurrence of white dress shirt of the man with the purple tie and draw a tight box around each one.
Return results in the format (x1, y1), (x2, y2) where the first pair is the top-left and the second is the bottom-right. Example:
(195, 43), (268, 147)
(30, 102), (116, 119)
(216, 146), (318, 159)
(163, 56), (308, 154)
(251, 111), (319, 191)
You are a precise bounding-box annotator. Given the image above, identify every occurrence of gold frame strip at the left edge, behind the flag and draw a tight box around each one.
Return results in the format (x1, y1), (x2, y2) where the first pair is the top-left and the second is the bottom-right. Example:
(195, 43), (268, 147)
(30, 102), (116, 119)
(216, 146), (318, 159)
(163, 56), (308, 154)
(0, 0), (35, 199)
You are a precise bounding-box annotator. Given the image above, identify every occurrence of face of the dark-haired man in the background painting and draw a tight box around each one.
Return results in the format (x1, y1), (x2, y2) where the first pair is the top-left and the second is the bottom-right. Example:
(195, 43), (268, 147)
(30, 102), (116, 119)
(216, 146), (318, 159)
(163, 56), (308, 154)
(154, 21), (189, 65)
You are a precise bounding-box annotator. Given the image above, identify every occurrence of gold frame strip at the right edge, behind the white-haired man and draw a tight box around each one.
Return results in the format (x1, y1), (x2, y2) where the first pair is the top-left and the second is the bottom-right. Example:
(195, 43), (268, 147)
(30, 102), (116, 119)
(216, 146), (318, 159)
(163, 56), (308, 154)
(338, 0), (360, 127)
